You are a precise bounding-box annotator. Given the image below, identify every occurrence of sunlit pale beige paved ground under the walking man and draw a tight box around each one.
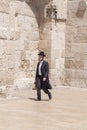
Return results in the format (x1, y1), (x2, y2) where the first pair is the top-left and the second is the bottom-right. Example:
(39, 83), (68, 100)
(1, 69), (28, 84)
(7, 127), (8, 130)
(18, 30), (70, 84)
(0, 87), (87, 130)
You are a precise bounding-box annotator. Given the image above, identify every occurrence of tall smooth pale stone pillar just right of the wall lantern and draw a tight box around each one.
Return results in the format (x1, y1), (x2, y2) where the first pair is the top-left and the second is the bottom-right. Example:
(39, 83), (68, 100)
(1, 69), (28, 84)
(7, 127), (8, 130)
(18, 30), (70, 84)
(51, 0), (67, 86)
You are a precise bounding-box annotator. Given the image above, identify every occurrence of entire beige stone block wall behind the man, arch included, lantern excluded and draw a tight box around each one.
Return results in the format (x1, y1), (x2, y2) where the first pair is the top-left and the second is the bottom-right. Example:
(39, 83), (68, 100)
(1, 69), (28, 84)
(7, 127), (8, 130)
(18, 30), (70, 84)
(0, 0), (87, 87)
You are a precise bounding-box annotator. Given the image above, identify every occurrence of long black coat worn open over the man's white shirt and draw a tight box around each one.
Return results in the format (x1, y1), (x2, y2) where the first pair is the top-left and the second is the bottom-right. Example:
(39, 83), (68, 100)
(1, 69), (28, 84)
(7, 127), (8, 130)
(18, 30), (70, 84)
(35, 61), (52, 89)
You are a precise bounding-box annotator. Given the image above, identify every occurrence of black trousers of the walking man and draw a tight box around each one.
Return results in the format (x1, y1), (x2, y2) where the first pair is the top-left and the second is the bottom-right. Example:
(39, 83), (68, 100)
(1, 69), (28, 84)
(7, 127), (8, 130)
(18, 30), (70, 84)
(36, 76), (51, 100)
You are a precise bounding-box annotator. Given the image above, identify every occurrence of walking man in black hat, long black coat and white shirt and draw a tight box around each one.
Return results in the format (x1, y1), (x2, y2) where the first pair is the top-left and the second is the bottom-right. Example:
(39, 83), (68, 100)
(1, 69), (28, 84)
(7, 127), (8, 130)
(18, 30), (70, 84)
(35, 51), (52, 101)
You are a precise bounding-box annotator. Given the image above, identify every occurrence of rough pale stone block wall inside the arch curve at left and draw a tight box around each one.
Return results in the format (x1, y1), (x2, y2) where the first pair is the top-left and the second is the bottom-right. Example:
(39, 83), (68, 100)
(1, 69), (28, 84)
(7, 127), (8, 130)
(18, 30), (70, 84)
(0, 0), (39, 85)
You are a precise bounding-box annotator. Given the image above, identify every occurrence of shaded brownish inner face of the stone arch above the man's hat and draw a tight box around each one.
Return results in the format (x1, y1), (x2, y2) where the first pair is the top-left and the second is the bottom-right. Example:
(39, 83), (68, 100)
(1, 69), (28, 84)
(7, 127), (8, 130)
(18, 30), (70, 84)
(18, 0), (51, 71)
